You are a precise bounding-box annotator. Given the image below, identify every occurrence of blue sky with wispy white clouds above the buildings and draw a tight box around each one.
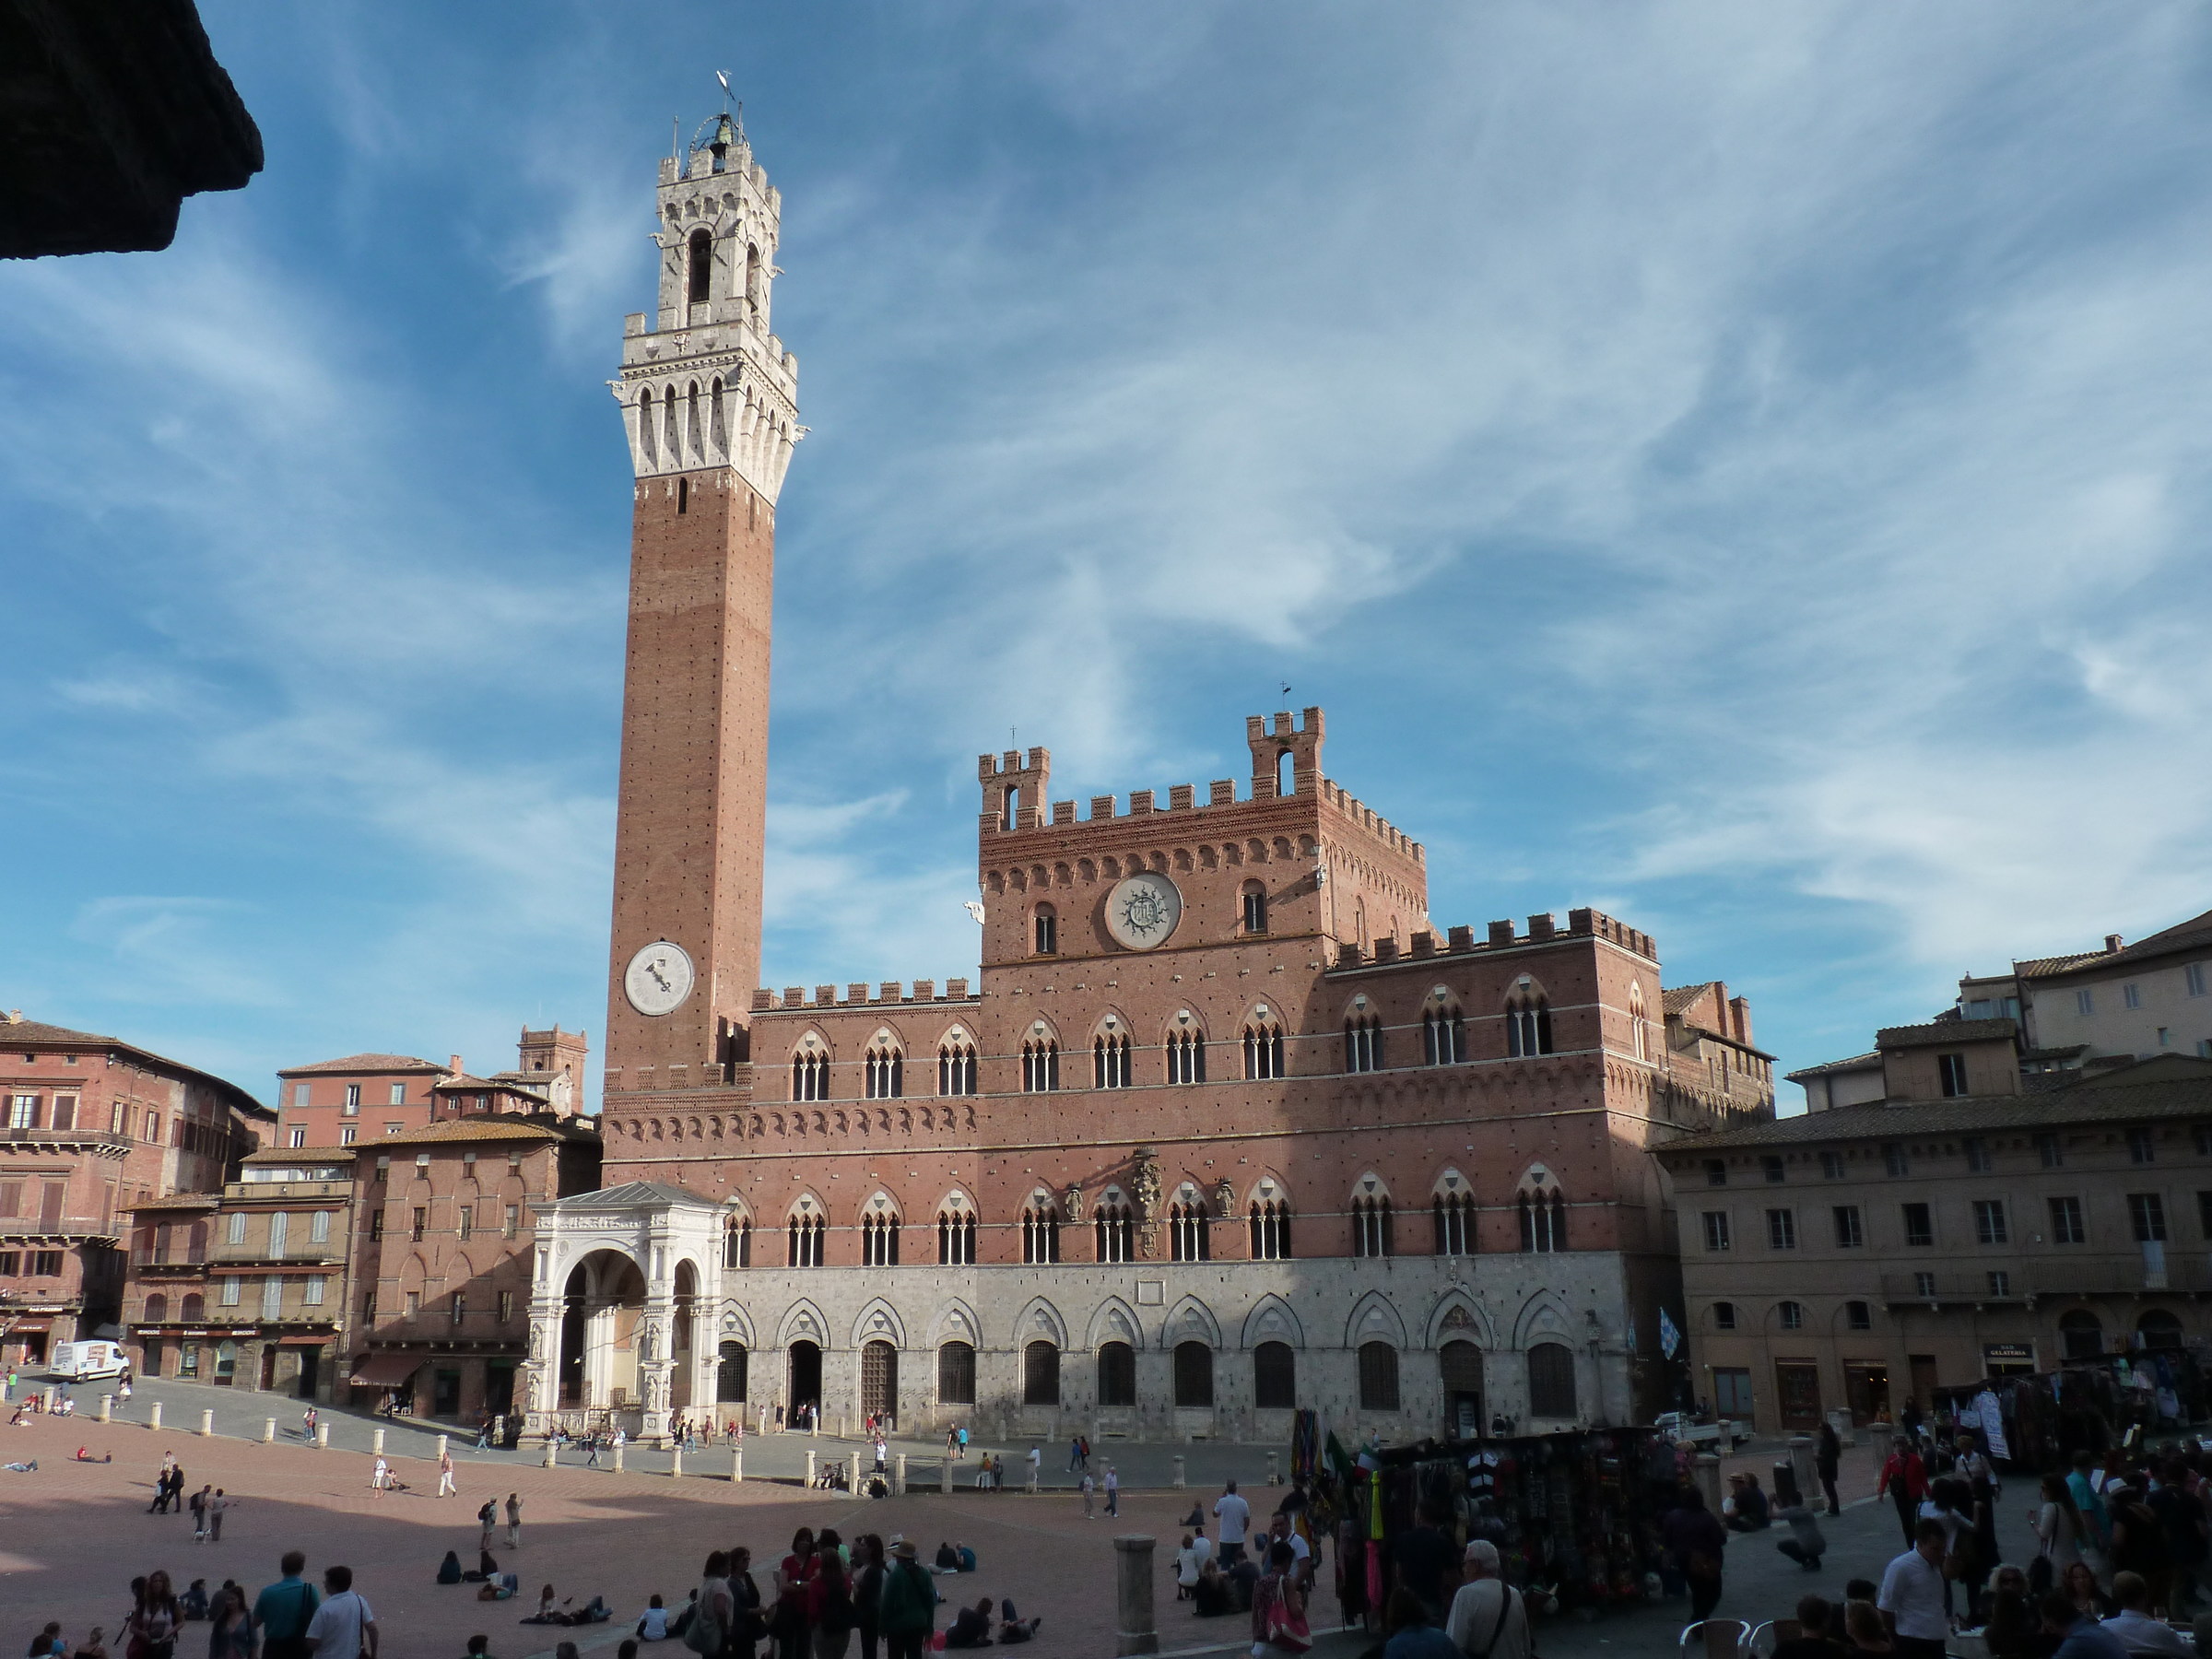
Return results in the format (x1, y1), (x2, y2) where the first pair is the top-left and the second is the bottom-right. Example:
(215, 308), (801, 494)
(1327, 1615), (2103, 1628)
(0, 0), (2212, 1104)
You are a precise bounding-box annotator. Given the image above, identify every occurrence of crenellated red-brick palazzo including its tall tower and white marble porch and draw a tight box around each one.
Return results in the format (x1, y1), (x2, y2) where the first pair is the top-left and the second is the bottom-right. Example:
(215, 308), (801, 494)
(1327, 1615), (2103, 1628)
(522, 120), (1774, 1438)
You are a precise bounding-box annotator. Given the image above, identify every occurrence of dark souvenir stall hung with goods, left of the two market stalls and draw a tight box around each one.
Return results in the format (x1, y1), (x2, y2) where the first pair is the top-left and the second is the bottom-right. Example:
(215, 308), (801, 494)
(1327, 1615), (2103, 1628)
(1316, 1429), (1675, 1615)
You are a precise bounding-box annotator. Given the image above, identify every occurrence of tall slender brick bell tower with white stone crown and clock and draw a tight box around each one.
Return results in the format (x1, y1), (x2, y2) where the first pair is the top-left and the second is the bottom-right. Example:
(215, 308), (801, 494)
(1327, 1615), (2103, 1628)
(606, 115), (806, 1095)
